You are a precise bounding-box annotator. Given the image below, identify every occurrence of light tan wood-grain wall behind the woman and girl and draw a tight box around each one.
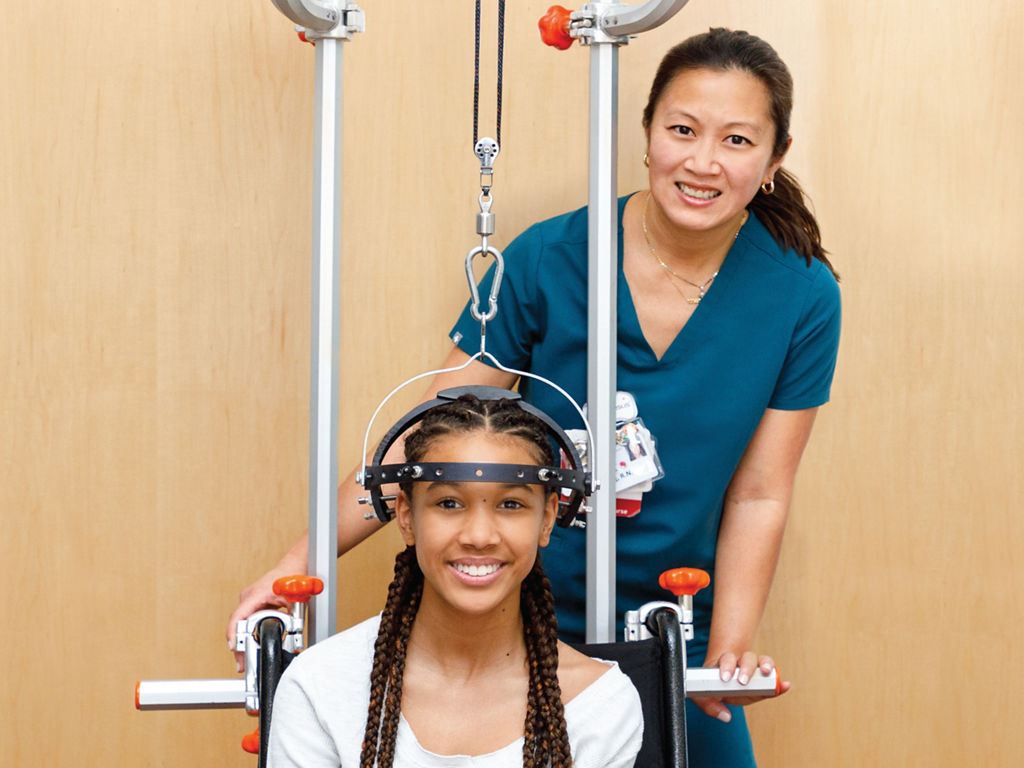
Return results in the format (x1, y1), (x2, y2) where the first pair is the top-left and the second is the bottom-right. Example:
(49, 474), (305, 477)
(0, 0), (1024, 767)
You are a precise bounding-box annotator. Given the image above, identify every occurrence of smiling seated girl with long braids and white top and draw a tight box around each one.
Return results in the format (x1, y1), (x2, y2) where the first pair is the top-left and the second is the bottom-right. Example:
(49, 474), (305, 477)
(269, 392), (643, 768)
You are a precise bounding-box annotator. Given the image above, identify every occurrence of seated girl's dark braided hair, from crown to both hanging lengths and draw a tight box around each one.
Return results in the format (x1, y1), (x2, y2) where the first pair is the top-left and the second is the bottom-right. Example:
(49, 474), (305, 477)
(359, 395), (572, 768)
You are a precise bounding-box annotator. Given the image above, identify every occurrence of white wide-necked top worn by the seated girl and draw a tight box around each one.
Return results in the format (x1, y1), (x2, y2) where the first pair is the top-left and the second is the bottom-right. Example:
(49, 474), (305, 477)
(267, 615), (643, 768)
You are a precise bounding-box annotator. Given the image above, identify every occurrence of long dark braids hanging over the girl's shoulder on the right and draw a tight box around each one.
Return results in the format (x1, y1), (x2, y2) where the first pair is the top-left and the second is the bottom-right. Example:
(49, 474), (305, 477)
(520, 554), (572, 768)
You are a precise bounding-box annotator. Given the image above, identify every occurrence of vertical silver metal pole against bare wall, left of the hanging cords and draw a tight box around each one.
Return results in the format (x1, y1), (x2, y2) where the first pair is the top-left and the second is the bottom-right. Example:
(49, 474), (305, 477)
(307, 38), (342, 645)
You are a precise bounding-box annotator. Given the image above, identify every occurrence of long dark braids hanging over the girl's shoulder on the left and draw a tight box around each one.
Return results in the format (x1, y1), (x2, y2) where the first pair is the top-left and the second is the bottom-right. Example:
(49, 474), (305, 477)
(359, 547), (423, 768)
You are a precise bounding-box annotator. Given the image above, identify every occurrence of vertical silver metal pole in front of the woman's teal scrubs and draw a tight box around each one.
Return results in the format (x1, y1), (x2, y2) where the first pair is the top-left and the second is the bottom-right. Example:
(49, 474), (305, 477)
(587, 37), (618, 643)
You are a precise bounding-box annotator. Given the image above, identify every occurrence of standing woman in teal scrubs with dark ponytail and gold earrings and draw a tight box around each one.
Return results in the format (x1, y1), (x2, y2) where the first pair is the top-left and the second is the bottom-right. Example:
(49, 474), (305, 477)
(229, 29), (840, 767)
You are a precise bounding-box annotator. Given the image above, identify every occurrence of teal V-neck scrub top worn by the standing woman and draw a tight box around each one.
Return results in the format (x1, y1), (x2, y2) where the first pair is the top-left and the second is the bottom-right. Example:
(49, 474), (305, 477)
(452, 192), (840, 664)
